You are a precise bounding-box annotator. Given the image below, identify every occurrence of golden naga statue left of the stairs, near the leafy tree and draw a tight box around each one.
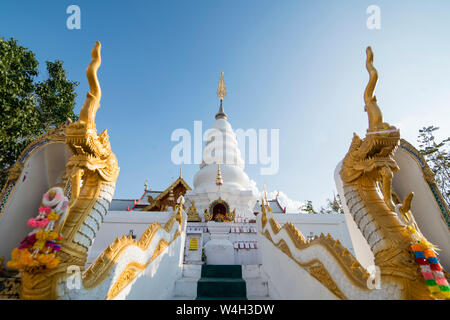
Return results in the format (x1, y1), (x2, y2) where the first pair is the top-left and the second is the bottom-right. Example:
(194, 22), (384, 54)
(21, 41), (119, 299)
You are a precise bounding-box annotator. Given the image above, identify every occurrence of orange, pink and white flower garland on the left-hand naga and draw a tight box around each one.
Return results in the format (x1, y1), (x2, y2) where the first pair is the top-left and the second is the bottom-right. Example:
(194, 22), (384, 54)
(7, 187), (69, 270)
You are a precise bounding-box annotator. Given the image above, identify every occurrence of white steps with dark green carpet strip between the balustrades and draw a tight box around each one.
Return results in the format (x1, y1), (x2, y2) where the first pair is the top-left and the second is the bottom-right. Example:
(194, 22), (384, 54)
(173, 264), (270, 300)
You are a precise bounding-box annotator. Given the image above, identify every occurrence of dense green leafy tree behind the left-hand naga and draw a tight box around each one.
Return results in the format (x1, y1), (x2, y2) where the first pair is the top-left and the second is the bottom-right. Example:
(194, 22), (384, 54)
(0, 38), (78, 186)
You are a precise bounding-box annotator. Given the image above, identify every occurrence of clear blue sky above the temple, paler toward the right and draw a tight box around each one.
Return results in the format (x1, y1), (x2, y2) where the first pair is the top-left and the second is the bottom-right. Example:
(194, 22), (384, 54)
(0, 0), (450, 207)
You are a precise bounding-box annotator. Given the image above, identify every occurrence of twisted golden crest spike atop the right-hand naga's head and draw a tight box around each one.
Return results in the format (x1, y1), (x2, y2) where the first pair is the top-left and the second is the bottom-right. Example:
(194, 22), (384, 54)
(364, 47), (383, 131)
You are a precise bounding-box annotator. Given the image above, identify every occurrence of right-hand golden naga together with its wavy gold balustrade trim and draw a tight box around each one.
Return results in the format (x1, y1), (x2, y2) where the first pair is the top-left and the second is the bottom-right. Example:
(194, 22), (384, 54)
(261, 47), (442, 299)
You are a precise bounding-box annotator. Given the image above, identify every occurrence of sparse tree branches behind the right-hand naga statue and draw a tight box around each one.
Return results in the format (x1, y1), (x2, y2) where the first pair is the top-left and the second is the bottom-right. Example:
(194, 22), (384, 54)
(417, 126), (450, 206)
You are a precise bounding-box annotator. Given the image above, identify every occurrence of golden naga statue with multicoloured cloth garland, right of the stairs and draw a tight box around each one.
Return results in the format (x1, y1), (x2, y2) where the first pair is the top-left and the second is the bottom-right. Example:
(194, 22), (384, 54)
(340, 47), (440, 299)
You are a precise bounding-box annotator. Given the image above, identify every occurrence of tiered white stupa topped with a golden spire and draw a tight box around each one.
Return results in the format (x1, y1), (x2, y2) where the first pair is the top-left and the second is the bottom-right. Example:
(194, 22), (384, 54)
(186, 72), (258, 218)
